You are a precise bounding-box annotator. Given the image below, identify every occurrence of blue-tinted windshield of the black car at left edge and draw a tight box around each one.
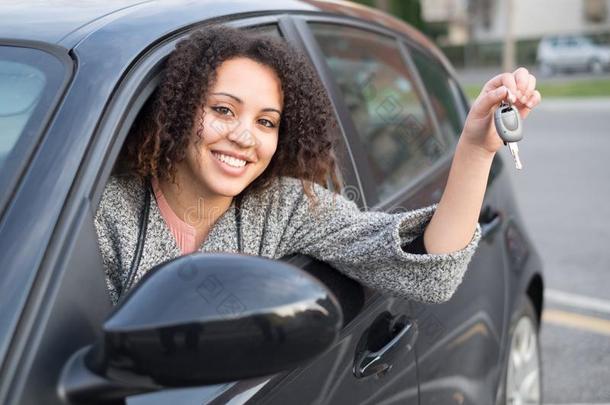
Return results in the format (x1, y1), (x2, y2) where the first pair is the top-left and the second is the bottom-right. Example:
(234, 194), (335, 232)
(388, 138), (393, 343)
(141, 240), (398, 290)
(0, 46), (65, 204)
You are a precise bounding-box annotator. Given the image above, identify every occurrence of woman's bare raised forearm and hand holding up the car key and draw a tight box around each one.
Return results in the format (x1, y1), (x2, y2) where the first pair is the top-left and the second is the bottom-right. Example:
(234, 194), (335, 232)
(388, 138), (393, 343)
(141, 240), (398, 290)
(424, 68), (541, 253)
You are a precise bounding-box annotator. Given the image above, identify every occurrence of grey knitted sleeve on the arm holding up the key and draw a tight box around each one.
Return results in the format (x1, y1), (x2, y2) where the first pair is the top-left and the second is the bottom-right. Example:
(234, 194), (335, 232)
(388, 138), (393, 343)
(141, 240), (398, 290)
(282, 178), (481, 303)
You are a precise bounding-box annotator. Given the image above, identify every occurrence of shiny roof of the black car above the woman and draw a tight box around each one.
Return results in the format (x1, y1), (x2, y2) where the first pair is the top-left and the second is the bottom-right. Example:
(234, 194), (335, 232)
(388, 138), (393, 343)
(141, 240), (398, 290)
(0, 0), (434, 49)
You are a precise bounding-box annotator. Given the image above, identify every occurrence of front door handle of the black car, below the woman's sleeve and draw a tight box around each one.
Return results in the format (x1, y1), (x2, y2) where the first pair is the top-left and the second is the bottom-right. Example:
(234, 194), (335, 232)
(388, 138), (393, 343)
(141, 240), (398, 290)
(353, 320), (418, 378)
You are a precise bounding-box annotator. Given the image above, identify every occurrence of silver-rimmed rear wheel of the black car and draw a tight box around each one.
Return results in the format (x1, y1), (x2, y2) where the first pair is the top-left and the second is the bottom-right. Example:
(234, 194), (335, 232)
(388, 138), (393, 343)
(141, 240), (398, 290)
(503, 298), (542, 405)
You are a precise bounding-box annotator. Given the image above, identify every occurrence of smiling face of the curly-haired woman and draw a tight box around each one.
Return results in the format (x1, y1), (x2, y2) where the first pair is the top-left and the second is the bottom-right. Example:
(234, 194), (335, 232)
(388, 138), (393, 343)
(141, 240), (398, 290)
(176, 57), (283, 198)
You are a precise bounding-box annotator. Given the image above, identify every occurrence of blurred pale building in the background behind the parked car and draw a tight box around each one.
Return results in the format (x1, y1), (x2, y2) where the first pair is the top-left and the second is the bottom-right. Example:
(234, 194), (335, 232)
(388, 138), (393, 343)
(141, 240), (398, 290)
(421, 0), (610, 66)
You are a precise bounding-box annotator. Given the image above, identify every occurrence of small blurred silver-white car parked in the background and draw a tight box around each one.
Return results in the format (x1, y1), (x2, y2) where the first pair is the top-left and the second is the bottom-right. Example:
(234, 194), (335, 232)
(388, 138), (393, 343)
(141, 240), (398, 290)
(536, 35), (610, 75)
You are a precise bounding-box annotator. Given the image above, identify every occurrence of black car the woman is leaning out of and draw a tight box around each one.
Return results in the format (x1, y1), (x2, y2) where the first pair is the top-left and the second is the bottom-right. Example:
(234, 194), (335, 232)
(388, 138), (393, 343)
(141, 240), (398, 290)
(0, 0), (543, 405)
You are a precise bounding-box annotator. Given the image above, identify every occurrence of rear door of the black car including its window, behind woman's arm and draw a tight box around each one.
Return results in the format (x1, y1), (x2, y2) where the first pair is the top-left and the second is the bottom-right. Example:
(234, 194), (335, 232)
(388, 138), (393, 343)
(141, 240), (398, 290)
(300, 17), (507, 404)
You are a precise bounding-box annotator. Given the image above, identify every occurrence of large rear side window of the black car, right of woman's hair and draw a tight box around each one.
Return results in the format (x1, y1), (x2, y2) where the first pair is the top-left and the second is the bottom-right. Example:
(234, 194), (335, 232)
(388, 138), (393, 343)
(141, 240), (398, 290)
(310, 23), (444, 199)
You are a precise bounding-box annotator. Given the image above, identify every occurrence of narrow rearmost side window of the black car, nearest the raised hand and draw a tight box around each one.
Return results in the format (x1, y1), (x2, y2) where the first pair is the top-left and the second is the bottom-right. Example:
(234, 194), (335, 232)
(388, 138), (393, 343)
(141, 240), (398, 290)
(410, 45), (464, 143)
